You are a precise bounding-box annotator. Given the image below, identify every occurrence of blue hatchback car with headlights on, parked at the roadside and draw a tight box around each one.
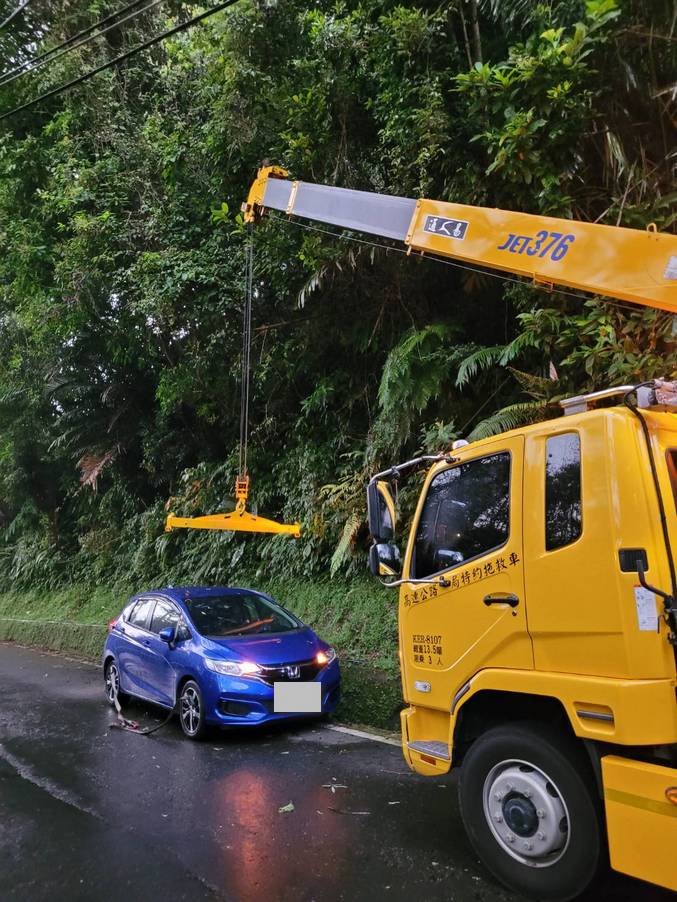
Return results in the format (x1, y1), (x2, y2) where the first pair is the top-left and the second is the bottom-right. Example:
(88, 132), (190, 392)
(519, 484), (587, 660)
(103, 587), (341, 739)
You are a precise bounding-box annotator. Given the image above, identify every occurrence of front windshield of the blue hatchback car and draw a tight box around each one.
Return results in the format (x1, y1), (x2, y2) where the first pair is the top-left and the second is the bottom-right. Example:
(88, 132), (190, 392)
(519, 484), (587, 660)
(184, 591), (300, 638)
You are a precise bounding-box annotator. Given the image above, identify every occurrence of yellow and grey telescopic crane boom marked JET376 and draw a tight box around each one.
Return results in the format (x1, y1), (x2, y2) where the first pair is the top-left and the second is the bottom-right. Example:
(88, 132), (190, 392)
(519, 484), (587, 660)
(243, 167), (677, 313)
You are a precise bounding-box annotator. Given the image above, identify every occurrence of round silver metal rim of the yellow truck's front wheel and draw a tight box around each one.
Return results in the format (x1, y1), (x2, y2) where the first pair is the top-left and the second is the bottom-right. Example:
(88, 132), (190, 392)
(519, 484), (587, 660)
(482, 759), (571, 868)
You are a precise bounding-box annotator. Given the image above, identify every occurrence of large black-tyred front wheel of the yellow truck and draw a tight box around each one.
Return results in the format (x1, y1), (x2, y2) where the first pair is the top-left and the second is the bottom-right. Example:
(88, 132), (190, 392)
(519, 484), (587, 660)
(459, 723), (604, 902)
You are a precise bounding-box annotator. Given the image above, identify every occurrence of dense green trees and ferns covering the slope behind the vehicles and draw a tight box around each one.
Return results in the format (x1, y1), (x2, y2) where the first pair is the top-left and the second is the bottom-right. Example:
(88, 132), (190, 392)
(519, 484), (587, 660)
(0, 0), (677, 616)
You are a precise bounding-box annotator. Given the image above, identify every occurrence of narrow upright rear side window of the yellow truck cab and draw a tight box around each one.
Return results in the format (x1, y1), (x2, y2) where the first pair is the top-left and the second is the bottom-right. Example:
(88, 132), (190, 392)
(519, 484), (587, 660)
(545, 432), (582, 551)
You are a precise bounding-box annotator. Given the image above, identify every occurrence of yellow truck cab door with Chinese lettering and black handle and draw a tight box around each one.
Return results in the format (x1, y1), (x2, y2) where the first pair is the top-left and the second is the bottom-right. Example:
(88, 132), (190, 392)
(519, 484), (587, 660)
(400, 436), (533, 717)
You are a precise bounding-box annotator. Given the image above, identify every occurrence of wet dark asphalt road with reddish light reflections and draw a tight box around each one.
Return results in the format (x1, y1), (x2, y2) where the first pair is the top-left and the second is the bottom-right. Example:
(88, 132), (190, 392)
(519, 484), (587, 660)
(0, 643), (674, 902)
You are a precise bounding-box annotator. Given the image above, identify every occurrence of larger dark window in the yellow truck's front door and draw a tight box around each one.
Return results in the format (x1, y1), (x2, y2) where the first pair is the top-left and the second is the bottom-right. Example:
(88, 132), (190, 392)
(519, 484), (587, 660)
(413, 451), (510, 579)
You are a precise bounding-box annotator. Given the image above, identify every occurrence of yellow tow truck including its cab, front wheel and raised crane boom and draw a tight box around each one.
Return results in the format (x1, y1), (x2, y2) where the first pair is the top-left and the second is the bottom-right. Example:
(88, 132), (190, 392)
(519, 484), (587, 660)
(243, 167), (677, 900)
